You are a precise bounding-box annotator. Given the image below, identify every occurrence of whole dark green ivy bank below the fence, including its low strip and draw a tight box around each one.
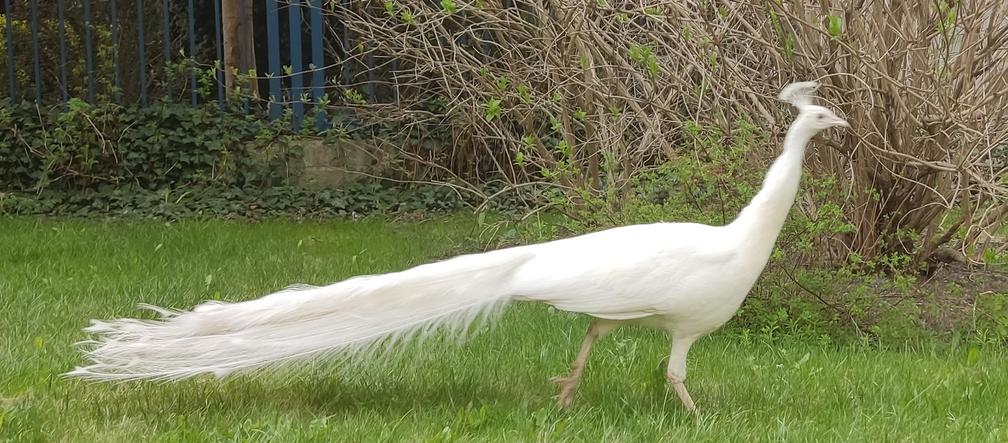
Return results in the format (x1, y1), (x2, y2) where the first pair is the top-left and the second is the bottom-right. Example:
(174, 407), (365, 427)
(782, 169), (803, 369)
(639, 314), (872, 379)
(0, 100), (536, 218)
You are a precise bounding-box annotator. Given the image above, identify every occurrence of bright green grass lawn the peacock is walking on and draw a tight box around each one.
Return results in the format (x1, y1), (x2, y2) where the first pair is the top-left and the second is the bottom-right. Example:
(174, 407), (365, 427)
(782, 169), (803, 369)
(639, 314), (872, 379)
(0, 217), (1008, 442)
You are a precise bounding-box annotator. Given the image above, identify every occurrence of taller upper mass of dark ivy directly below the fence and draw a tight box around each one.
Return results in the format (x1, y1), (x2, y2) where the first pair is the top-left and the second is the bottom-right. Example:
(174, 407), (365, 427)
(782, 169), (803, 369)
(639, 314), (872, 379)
(0, 99), (296, 193)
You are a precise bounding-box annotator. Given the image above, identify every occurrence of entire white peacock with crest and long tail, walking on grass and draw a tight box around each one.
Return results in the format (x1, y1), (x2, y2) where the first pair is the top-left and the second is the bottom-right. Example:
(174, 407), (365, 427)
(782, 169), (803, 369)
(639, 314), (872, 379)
(70, 82), (847, 410)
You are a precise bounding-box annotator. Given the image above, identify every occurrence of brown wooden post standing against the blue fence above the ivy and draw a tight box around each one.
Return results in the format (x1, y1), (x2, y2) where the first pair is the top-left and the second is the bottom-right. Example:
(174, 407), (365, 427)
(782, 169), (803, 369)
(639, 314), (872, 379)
(221, 0), (259, 97)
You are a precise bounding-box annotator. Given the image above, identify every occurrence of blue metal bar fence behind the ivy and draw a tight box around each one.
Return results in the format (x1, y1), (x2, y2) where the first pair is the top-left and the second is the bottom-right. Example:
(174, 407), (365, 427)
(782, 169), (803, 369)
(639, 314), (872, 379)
(0, 0), (364, 129)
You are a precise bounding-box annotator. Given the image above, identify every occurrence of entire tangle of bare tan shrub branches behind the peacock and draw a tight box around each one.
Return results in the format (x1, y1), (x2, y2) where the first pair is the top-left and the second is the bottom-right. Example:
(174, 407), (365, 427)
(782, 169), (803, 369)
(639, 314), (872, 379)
(329, 0), (1008, 265)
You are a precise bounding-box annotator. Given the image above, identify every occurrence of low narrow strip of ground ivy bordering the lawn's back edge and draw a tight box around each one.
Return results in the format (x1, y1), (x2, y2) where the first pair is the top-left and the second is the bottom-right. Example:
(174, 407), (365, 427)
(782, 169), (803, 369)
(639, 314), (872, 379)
(0, 182), (527, 219)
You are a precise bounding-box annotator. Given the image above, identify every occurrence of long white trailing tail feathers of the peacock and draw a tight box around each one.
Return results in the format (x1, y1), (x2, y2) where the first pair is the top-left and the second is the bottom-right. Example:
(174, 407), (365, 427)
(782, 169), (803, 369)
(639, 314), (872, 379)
(68, 248), (531, 380)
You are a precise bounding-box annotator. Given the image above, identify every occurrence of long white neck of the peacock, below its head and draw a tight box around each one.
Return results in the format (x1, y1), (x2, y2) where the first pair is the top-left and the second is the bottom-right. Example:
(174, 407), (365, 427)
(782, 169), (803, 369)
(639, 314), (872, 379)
(729, 120), (815, 258)
